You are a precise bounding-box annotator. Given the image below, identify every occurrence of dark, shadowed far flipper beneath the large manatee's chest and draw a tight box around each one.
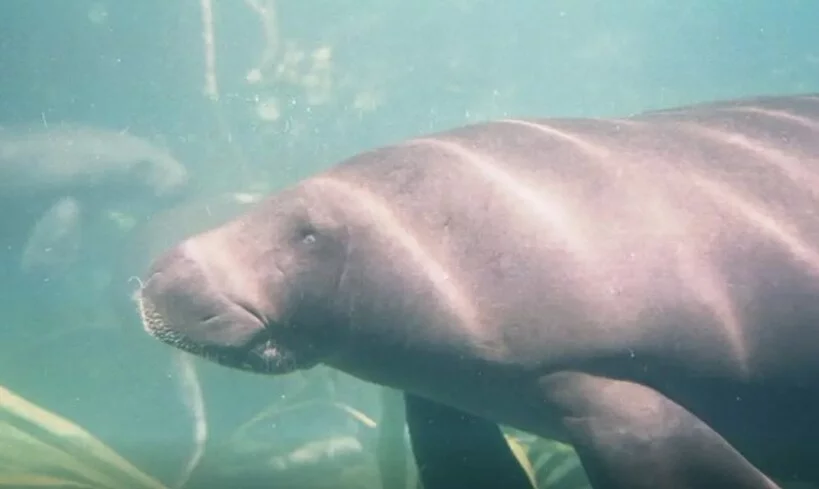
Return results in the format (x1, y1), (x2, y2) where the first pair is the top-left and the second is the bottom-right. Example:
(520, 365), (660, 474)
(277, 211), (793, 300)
(404, 394), (532, 489)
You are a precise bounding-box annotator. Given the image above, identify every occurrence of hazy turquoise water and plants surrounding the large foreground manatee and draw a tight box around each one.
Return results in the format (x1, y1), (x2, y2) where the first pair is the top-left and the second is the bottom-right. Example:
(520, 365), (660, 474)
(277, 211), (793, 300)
(0, 0), (819, 489)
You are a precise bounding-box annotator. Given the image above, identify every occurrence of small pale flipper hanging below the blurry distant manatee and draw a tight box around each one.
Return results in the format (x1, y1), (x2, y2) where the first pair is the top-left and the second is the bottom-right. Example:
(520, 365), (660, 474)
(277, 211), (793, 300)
(20, 197), (82, 277)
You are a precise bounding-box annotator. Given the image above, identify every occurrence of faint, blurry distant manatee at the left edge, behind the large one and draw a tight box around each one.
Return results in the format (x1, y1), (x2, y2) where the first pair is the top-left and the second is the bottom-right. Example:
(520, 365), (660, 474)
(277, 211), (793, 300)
(0, 124), (188, 276)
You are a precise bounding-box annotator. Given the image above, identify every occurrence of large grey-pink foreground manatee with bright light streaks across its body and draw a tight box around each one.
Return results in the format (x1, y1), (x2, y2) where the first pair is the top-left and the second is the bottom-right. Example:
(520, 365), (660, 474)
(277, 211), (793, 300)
(140, 95), (819, 489)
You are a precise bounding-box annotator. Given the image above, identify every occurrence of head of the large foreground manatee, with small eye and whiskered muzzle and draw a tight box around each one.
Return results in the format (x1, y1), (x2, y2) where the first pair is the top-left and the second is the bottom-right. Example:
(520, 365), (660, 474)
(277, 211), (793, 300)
(137, 185), (349, 374)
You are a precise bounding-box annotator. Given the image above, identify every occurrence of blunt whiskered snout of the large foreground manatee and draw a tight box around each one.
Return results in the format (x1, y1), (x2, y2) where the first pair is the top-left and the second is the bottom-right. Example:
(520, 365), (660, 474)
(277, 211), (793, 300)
(137, 240), (287, 373)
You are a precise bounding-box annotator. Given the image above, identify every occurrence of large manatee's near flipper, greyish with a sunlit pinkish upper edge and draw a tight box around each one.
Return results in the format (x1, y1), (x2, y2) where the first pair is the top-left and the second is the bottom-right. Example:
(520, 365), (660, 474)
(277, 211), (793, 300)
(542, 373), (779, 489)
